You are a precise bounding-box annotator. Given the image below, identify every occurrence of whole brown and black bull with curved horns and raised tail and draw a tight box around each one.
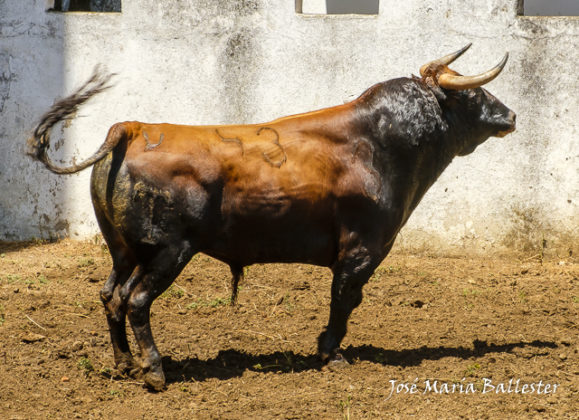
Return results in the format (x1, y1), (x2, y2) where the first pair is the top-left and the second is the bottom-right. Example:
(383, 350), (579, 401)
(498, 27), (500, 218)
(29, 44), (515, 390)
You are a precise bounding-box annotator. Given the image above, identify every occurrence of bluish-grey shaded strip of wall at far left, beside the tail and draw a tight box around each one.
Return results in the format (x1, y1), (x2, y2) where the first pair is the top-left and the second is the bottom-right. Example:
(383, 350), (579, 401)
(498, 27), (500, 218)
(0, 1), (67, 240)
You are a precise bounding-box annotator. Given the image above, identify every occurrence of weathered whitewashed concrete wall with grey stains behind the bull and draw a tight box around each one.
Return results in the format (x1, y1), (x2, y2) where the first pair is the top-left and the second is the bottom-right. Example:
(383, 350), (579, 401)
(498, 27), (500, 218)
(0, 0), (579, 252)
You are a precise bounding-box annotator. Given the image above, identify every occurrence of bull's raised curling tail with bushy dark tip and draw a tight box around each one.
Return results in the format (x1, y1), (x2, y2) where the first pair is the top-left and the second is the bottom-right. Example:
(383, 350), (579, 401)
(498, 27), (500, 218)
(28, 66), (123, 174)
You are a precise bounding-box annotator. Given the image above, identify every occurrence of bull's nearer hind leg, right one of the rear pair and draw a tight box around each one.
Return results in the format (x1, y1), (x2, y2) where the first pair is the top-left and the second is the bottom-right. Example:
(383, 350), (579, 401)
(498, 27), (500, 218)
(127, 242), (195, 391)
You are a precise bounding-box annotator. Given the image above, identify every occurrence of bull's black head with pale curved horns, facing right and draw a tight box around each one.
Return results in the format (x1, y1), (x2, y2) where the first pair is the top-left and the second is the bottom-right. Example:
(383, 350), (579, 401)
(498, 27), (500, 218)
(420, 44), (516, 155)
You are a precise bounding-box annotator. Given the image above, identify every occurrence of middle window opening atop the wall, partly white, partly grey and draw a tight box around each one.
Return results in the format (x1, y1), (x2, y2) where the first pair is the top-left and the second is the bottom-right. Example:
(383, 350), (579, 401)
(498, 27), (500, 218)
(296, 0), (380, 15)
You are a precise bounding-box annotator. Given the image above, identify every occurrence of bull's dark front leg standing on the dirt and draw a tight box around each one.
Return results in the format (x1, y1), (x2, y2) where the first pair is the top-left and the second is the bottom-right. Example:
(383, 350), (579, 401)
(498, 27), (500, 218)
(318, 249), (381, 363)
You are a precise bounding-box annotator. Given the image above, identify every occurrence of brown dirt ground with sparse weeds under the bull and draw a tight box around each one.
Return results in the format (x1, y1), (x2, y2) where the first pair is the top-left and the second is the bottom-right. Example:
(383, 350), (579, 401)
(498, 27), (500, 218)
(0, 240), (579, 419)
